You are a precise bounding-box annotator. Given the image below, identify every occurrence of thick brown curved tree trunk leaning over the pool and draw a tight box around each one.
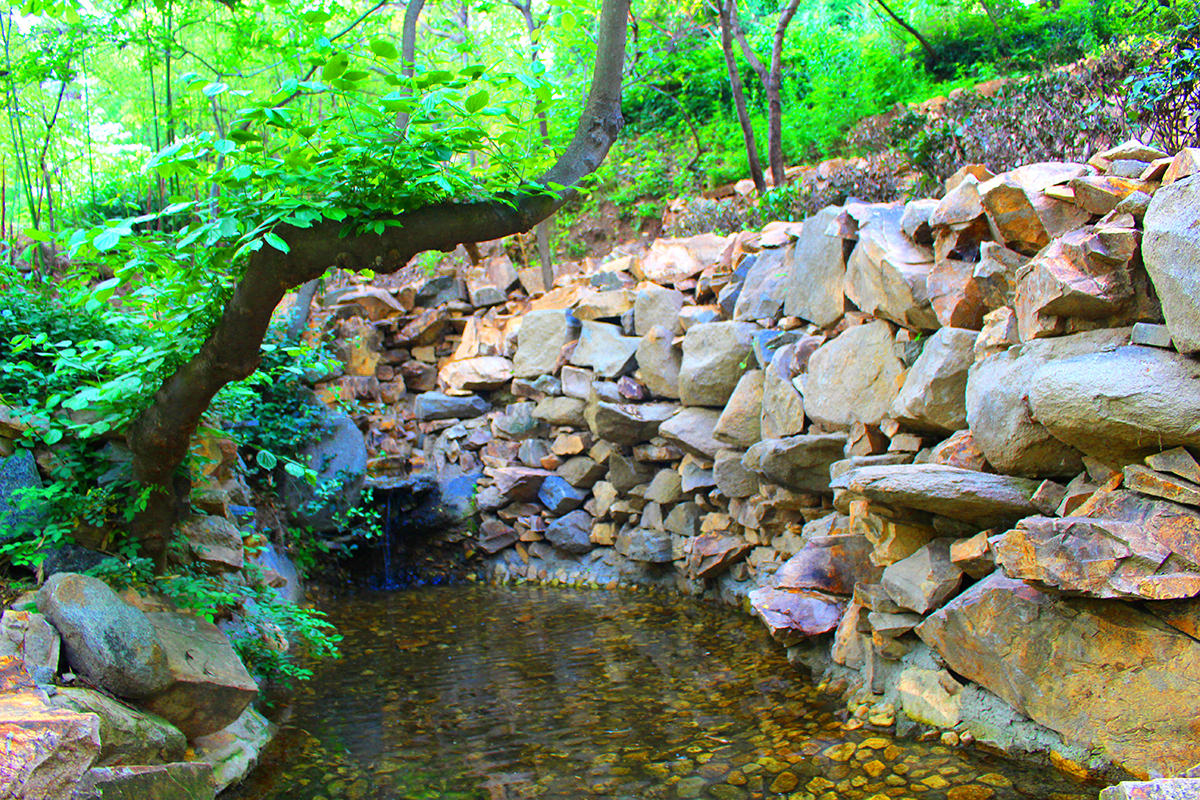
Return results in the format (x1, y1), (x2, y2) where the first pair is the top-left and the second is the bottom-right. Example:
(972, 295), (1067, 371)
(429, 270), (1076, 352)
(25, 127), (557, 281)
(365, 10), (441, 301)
(128, 0), (630, 570)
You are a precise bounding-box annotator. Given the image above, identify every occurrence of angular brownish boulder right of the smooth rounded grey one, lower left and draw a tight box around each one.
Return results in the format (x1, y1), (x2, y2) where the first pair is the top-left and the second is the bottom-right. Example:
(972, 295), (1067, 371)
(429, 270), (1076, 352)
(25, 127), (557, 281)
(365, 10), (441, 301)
(139, 612), (258, 739)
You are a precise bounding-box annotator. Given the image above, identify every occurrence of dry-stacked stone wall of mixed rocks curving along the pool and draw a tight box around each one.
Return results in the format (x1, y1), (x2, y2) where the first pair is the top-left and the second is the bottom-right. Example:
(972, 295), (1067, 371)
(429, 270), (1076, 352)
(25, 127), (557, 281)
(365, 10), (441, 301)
(324, 143), (1200, 776)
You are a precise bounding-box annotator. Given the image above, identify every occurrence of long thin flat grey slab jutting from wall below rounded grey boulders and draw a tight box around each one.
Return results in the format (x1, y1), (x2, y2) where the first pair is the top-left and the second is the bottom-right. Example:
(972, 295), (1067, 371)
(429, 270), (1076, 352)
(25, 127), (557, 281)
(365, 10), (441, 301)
(830, 464), (1039, 528)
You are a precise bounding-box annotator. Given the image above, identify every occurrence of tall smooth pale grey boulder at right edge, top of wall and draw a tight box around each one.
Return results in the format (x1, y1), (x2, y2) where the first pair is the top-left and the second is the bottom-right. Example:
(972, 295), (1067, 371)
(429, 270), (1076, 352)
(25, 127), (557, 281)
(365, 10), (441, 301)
(1141, 175), (1200, 353)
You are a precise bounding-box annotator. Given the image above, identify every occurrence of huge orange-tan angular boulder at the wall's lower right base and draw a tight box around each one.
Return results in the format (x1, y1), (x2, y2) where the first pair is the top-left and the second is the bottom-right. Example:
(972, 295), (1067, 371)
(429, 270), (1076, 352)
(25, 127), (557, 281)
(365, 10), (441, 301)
(917, 573), (1200, 775)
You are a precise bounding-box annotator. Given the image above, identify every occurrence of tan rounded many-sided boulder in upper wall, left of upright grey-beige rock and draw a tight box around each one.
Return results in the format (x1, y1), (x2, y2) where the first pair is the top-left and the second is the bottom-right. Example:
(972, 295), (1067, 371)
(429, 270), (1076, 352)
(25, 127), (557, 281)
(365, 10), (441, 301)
(802, 320), (905, 431)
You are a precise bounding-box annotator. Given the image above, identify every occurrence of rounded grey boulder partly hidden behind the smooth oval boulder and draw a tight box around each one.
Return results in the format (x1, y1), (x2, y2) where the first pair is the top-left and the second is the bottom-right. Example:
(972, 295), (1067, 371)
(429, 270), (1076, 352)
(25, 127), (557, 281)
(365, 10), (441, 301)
(966, 329), (1129, 477)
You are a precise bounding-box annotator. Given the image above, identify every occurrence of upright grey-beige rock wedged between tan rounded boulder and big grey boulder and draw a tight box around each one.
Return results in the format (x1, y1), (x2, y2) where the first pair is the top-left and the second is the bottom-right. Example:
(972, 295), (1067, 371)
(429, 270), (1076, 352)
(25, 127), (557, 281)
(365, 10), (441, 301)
(892, 327), (978, 433)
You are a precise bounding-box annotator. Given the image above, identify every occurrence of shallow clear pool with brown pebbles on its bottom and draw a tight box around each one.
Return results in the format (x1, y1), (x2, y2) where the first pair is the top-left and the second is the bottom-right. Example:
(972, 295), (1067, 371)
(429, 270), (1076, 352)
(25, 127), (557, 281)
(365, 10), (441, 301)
(226, 587), (1098, 800)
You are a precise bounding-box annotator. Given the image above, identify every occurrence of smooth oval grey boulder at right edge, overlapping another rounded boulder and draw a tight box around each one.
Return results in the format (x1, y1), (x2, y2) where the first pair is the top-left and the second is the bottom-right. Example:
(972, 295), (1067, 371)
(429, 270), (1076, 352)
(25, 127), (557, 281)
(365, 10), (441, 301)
(1028, 345), (1200, 467)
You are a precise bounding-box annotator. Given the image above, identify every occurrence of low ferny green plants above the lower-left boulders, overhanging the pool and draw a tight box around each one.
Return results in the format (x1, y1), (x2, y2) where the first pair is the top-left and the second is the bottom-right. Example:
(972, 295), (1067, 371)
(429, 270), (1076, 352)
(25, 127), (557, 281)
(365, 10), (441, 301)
(88, 558), (342, 687)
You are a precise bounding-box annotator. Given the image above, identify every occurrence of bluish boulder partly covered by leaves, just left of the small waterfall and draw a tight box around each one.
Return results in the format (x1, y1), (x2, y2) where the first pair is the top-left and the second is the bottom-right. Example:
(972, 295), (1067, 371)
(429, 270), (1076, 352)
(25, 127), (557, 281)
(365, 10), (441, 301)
(280, 414), (367, 531)
